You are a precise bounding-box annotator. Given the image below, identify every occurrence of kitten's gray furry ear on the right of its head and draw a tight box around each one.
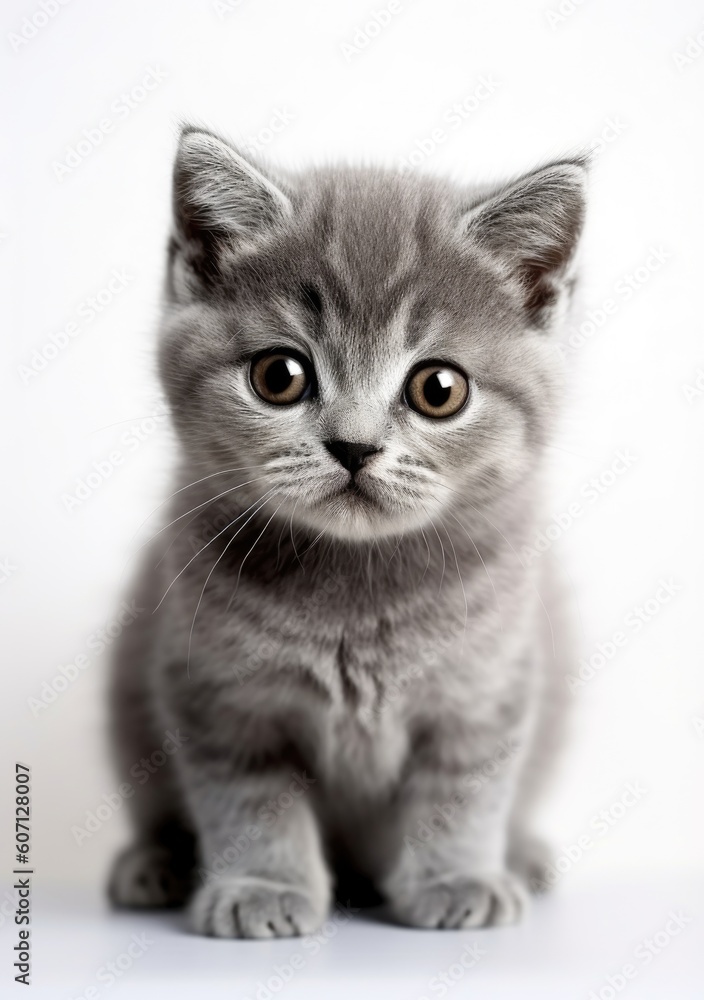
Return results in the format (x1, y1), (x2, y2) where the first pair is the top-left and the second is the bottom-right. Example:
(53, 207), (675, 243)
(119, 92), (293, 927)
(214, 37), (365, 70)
(461, 157), (587, 327)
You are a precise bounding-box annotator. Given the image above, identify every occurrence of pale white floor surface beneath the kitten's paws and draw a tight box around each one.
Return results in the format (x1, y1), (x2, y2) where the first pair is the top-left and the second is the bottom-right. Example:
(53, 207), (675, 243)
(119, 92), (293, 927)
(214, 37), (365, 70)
(9, 878), (704, 1000)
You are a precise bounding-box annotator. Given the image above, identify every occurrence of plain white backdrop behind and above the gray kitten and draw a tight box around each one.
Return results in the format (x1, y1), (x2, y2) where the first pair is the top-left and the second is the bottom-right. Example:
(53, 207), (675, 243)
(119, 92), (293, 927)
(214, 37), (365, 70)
(0, 0), (704, 995)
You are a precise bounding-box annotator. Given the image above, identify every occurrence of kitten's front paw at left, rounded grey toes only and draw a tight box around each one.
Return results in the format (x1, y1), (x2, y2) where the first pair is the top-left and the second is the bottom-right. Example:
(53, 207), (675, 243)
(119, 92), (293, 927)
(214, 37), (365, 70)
(191, 875), (328, 938)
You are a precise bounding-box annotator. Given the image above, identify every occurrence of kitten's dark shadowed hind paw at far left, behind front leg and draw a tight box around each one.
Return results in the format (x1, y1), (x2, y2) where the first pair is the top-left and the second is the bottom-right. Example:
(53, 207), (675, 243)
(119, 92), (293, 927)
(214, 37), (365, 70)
(108, 844), (191, 908)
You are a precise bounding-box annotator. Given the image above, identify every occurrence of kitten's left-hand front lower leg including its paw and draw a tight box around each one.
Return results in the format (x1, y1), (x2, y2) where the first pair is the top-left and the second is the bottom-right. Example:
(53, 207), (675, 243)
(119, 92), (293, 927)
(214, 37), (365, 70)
(175, 726), (331, 938)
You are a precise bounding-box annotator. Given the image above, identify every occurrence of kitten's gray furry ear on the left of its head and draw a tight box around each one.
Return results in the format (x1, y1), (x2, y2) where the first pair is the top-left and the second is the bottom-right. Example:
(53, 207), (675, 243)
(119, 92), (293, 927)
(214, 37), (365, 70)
(173, 126), (291, 282)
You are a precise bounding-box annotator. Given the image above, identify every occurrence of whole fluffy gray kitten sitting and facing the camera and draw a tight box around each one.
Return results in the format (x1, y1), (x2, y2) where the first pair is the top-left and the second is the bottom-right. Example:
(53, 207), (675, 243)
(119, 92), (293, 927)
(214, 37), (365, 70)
(110, 128), (585, 937)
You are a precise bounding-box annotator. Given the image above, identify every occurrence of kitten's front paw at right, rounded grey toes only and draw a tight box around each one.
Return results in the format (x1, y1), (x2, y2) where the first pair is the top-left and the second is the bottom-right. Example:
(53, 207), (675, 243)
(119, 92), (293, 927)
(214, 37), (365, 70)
(391, 872), (526, 929)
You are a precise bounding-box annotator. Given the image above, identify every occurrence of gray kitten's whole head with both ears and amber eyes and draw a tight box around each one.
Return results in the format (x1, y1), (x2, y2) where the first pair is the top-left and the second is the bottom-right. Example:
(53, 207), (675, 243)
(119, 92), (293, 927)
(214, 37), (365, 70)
(160, 128), (585, 539)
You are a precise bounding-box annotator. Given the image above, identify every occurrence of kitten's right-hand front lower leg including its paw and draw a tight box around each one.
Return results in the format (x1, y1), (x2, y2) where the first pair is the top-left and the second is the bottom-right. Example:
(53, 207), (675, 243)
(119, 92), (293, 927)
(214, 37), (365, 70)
(382, 732), (526, 928)
